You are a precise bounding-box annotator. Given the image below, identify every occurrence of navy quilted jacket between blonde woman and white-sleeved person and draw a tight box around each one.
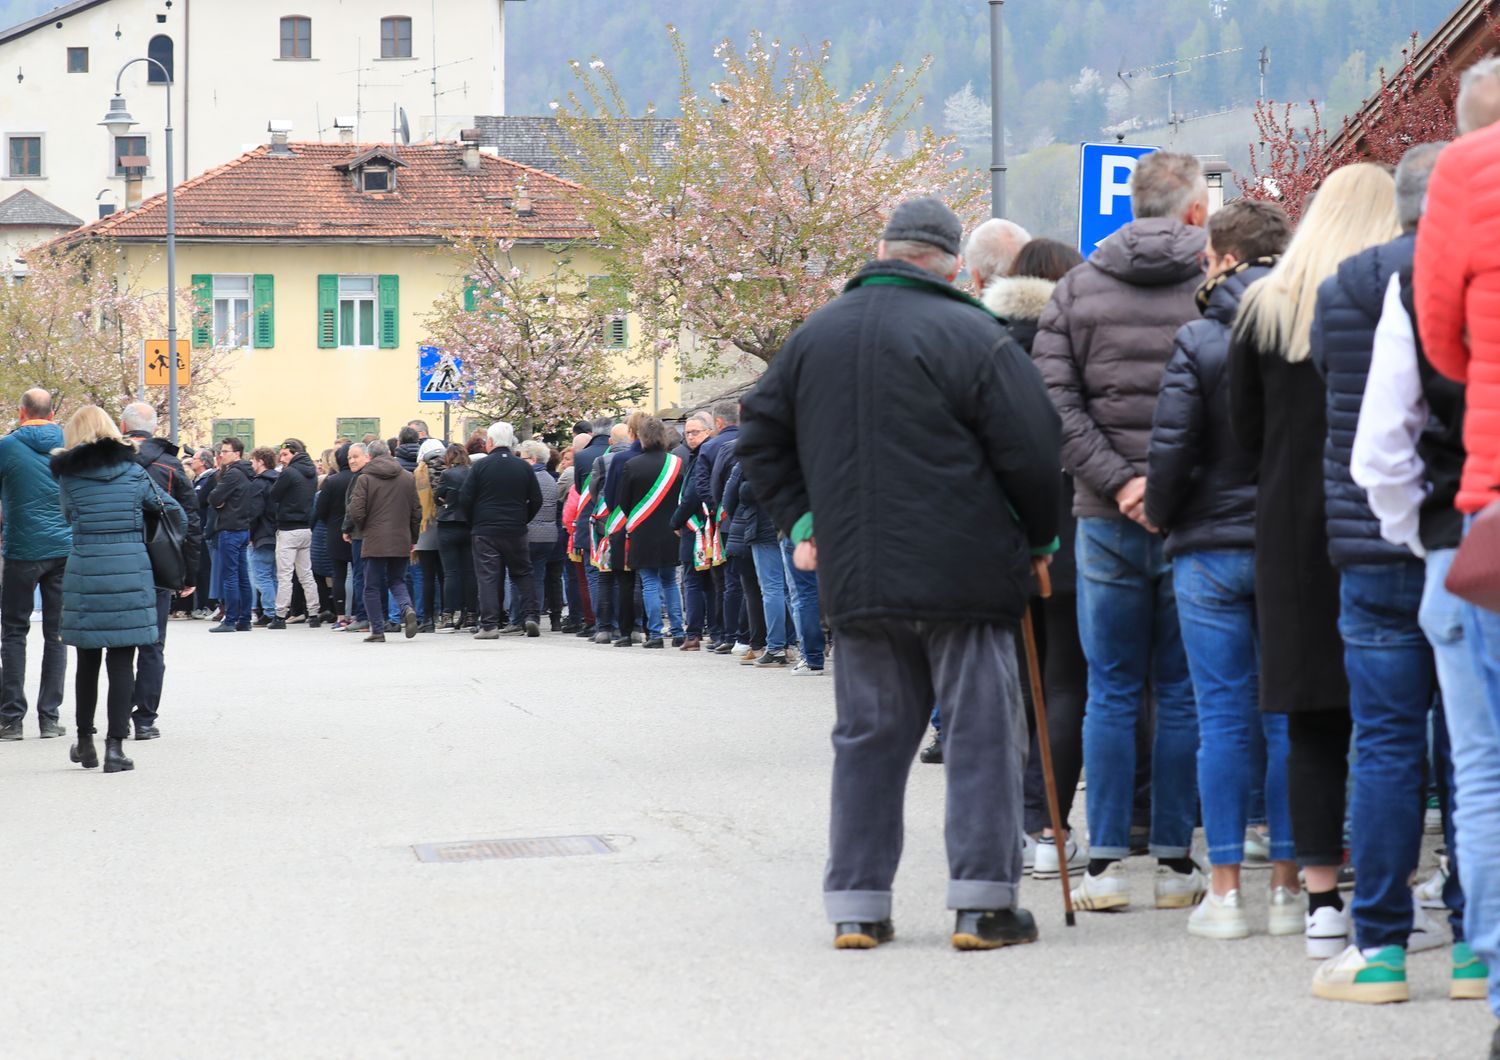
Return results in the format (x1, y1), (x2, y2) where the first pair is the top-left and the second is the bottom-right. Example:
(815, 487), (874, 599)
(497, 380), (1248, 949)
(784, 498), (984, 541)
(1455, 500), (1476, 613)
(1311, 234), (1416, 567)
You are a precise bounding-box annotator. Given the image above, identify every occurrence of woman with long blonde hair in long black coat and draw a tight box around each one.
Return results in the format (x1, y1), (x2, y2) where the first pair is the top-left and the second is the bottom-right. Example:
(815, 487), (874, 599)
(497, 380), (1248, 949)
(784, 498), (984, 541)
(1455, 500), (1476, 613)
(1229, 162), (1400, 958)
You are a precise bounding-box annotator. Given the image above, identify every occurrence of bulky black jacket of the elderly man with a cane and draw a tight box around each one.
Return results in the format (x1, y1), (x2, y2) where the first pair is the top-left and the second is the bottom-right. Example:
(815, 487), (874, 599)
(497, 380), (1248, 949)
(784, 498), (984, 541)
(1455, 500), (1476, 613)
(737, 261), (1062, 625)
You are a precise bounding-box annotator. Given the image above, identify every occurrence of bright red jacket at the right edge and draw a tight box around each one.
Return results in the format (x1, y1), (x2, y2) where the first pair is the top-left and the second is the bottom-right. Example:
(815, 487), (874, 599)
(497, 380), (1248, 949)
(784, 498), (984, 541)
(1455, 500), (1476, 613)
(1415, 124), (1500, 513)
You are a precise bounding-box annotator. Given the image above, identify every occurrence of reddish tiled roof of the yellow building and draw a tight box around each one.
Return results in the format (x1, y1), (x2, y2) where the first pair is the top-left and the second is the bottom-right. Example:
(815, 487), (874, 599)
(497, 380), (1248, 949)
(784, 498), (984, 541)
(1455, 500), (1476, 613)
(65, 144), (597, 241)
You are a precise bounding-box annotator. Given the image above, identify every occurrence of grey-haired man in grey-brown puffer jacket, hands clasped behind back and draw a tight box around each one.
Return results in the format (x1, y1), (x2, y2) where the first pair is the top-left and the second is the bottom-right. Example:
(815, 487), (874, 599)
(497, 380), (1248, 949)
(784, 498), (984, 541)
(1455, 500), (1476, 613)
(1032, 151), (1209, 910)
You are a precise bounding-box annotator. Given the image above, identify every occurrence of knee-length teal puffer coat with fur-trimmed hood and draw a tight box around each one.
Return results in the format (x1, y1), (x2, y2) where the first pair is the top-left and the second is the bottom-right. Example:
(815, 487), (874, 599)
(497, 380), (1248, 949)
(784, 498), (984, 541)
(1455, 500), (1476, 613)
(53, 438), (188, 648)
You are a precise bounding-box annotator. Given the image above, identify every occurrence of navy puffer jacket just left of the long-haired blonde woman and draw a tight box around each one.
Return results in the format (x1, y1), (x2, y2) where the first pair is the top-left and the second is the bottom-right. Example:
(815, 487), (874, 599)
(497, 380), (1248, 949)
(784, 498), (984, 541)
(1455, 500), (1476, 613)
(1146, 258), (1275, 556)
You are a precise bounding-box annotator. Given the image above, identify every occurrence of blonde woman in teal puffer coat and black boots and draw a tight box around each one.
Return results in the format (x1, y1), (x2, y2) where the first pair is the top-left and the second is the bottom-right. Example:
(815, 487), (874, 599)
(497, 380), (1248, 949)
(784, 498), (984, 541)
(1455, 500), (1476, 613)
(53, 405), (188, 774)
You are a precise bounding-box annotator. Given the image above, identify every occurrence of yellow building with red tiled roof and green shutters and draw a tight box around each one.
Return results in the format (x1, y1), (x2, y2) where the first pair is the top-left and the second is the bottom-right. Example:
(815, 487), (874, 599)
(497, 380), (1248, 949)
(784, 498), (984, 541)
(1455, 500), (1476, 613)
(54, 135), (680, 451)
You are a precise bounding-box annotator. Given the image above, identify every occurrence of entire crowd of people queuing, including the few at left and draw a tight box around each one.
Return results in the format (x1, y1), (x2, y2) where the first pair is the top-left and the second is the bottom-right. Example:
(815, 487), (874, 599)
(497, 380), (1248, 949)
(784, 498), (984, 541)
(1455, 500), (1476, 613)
(0, 51), (1500, 1041)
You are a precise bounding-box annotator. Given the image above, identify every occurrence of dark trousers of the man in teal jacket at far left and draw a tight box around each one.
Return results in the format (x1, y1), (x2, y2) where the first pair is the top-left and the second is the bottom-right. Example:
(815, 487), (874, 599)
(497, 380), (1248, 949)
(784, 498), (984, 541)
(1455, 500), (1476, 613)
(0, 556), (68, 726)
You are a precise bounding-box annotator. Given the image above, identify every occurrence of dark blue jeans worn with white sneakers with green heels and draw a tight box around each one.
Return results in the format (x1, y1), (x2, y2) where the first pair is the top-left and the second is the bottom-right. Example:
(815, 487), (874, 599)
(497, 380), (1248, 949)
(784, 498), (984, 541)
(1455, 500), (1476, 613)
(1338, 559), (1436, 949)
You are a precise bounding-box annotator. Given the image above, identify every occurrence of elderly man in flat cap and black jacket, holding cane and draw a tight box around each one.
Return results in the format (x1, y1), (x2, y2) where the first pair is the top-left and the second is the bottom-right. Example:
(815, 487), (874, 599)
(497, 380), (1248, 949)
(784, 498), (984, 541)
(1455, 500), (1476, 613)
(738, 198), (1061, 949)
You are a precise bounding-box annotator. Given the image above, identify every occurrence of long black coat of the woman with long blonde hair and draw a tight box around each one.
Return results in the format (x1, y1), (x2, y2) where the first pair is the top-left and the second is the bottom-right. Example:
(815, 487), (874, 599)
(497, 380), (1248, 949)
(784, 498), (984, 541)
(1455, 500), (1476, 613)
(1229, 319), (1349, 714)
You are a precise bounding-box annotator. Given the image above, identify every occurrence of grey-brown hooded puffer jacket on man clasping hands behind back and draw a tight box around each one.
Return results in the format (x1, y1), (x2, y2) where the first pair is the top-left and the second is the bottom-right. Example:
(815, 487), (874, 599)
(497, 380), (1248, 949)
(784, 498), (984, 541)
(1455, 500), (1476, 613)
(1032, 217), (1206, 519)
